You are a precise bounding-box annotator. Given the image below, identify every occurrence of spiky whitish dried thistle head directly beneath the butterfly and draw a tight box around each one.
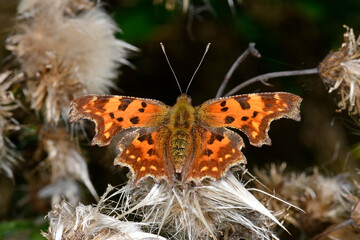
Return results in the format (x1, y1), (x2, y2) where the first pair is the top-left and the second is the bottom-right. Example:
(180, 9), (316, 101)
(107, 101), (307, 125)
(119, 173), (288, 239)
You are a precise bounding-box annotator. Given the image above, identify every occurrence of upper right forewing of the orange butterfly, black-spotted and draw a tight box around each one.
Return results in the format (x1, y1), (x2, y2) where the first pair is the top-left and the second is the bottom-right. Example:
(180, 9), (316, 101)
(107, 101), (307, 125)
(195, 92), (302, 146)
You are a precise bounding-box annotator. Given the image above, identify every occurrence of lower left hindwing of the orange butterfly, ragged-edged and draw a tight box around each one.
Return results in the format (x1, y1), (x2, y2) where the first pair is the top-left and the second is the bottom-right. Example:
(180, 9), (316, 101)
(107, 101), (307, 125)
(114, 127), (173, 185)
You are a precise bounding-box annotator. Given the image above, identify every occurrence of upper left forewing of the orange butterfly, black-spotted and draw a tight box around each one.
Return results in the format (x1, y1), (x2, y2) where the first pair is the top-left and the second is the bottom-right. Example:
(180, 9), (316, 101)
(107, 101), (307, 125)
(70, 95), (169, 146)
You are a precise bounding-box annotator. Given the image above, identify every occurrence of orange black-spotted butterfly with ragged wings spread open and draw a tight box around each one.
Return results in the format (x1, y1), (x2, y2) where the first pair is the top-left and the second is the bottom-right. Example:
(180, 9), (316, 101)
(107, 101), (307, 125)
(70, 92), (302, 186)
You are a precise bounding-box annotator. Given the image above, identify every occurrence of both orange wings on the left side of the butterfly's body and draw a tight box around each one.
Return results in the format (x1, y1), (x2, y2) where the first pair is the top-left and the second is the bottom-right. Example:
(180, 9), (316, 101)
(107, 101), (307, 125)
(70, 95), (172, 183)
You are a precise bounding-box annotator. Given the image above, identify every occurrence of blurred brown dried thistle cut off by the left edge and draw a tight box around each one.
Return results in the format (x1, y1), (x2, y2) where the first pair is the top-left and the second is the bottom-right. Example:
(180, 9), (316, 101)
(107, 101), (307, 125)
(0, 72), (21, 178)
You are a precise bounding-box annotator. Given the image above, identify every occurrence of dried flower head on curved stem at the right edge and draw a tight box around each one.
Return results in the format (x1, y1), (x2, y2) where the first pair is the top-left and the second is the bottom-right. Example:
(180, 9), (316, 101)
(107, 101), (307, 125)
(319, 26), (360, 115)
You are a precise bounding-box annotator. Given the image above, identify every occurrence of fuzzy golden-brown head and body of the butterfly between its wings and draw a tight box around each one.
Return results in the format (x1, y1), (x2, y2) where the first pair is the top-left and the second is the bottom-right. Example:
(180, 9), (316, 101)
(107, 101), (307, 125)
(168, 94), (195, 173)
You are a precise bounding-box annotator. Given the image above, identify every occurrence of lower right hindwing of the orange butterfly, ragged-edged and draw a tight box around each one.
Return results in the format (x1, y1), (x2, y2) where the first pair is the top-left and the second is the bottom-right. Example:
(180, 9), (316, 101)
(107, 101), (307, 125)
(182, 126), (246, 183)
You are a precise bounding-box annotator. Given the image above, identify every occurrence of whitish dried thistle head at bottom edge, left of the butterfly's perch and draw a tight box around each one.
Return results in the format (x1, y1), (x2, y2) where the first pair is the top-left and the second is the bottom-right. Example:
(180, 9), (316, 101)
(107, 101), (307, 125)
(42, 187), (165, 240)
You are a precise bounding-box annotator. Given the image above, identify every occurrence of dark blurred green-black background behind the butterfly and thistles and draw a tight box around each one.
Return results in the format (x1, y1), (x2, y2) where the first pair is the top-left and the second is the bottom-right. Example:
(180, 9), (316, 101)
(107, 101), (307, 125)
(0, 0), (360, 239)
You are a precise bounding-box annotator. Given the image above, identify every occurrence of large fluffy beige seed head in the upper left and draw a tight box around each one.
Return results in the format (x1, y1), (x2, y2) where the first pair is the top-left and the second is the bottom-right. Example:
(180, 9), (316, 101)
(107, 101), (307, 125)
(7, 0), (136, 124)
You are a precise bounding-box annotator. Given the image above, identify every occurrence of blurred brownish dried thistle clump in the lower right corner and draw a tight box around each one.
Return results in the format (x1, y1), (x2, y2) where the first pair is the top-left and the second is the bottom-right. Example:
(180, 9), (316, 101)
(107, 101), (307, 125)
(255, 164), (354, 235)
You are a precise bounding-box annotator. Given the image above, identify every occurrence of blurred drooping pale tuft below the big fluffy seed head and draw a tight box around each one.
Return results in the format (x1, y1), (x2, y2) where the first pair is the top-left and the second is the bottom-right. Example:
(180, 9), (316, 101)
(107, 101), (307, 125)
(39, 128), (98, 204)
